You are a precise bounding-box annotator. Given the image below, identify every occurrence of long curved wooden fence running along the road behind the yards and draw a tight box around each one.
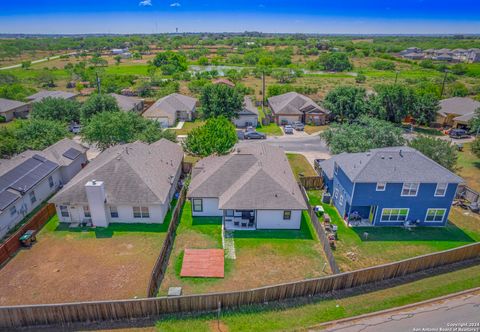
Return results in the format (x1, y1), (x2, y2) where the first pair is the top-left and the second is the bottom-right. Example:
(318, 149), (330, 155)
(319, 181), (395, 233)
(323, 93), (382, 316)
(0, 243), (480, 329)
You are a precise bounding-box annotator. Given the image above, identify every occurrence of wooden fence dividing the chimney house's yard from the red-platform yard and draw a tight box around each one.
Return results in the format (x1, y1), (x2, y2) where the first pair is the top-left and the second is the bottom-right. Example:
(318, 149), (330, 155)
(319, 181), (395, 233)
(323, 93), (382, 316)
(147, 186), (187, 297)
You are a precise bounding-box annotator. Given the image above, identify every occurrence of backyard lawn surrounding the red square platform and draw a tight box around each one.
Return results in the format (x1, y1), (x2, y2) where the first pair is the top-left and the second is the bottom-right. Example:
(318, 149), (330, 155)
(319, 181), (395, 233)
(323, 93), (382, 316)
(159, 201), (329, 295)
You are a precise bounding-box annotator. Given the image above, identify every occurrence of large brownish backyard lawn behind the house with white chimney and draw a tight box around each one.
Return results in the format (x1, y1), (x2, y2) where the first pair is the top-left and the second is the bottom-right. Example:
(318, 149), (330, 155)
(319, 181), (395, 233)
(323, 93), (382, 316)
(0, 216), (168, 305)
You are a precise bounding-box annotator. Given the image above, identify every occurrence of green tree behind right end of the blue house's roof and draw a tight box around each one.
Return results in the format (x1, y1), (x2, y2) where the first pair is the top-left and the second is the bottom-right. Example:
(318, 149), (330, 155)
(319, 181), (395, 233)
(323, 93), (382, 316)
(408, 135), (458, 171)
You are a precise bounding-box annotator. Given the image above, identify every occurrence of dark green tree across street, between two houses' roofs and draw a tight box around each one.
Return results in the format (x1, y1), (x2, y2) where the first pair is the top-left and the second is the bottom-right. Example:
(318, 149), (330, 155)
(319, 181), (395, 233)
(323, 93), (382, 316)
(200, 84), (243, 119)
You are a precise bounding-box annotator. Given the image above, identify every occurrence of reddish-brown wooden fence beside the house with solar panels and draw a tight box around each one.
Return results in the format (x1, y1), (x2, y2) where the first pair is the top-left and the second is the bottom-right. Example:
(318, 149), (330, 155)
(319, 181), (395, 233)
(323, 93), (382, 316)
(0, 204), (56, 266)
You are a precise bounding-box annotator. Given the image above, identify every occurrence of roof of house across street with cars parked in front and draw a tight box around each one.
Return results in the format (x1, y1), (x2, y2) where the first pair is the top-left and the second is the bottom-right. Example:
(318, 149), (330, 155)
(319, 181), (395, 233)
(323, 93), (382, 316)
(268, 92), (328, 115)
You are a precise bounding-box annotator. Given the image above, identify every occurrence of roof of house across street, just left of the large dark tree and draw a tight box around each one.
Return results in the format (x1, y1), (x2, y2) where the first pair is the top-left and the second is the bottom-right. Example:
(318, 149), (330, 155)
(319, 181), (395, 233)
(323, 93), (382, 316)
(143, 93), (197, 122)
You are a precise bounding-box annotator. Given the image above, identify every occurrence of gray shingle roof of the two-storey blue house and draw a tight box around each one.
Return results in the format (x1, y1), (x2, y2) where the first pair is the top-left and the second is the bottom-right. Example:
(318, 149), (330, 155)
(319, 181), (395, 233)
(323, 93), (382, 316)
(320, 146), (464, 183)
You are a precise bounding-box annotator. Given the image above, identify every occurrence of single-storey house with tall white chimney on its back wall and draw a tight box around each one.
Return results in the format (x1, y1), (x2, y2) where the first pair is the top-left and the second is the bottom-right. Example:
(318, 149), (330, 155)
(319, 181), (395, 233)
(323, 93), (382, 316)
(50, 139), (183, 227)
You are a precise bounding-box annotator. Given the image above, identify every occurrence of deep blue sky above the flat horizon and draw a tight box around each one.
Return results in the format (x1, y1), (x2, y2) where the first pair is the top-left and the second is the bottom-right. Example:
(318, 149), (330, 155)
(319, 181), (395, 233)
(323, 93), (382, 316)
(0, 0), (480, 34)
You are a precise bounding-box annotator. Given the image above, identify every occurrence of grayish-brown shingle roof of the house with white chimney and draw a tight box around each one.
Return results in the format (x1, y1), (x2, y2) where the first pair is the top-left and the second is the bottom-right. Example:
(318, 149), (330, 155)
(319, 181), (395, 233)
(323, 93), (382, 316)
(51, 139), (183, 205)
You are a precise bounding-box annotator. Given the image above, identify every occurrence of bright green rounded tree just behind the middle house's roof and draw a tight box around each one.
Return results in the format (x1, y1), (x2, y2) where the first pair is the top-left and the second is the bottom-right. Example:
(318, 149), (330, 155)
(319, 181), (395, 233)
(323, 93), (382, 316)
(183, 117), (238, 157)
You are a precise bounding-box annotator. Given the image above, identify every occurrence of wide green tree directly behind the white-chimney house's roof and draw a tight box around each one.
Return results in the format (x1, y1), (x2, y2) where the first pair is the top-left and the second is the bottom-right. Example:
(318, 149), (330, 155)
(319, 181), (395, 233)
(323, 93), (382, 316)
(82, 112), (176, 150)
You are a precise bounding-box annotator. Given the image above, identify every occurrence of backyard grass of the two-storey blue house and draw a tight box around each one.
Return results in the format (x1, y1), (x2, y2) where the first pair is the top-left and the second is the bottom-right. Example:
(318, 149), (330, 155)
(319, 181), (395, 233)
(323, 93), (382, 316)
(308, 190), (480, 271)
